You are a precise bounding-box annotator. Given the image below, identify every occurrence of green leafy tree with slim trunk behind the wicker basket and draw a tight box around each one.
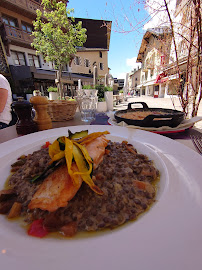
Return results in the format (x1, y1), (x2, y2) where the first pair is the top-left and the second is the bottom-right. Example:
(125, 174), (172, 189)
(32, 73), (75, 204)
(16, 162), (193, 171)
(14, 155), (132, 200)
(32, 0), (87, 97)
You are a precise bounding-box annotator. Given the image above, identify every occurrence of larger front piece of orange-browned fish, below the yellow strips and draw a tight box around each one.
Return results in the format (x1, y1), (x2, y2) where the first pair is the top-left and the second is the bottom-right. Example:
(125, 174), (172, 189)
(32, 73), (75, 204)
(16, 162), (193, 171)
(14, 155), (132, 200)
(28, 163), (82, 212)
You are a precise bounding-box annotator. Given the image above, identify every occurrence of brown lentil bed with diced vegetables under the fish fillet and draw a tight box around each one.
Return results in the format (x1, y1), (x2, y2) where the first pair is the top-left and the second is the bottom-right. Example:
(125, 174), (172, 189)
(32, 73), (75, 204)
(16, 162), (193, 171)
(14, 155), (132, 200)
(0, 131), (159, 237)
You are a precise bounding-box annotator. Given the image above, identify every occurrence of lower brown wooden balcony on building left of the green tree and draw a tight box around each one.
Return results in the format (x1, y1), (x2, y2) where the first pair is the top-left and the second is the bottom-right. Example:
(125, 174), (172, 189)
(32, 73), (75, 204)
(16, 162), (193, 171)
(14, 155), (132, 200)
(5, 25), (33, 45)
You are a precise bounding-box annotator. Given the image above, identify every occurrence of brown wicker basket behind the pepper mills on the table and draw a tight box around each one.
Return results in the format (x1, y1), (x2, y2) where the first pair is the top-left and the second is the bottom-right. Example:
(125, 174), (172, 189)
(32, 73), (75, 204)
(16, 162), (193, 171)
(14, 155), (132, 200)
(48, 100), (77, 122)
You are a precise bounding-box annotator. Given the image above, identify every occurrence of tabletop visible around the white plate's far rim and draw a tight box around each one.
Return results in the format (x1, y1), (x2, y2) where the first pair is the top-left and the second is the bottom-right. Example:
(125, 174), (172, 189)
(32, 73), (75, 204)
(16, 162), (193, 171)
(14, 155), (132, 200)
(0, 112), (202, 152)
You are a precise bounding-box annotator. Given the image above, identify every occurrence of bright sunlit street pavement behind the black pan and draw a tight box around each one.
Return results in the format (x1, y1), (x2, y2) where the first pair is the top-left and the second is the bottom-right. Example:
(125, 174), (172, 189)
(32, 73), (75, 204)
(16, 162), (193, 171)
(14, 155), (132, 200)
(114, 96), (202, 132)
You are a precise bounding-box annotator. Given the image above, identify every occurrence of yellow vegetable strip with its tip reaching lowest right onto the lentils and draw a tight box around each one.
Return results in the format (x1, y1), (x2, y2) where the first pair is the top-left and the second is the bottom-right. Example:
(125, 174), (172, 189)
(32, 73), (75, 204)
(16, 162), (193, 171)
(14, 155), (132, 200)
(73, 144), (104, 195)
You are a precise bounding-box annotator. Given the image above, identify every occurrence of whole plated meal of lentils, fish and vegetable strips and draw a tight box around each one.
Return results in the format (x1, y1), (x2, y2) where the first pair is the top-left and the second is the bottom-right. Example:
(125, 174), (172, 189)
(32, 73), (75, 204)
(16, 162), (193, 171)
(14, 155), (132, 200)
(0, 130), (159, 237)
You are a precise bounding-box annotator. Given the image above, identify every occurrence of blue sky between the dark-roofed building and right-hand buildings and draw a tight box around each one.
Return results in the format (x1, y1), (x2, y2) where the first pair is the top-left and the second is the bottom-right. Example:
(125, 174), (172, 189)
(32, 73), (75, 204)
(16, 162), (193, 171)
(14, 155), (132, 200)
(67, 0), (148, 78)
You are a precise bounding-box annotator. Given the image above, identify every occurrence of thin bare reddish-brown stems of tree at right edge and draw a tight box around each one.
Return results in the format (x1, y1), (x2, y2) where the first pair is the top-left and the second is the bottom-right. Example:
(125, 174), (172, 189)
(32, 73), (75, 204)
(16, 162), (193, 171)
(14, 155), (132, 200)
(164, 0), (202, 117)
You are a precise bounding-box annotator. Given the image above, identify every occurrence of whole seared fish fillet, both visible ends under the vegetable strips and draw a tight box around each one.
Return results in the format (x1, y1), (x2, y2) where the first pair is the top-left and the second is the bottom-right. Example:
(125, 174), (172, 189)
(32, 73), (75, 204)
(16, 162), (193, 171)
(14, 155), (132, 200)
(28, 135), (109, 212)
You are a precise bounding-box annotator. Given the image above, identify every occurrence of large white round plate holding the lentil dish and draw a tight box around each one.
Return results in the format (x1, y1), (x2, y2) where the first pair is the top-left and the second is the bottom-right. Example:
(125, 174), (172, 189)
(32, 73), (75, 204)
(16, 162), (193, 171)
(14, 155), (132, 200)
(0, 126), (202, 270)
